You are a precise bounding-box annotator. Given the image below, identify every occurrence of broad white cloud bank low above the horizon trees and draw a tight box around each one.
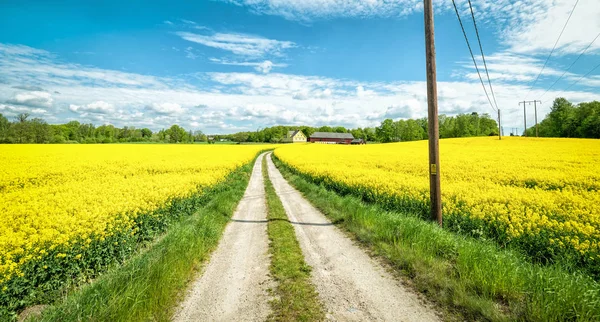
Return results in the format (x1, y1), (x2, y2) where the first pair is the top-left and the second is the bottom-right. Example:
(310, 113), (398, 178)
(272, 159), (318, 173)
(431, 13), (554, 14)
(0, 42), (600, 133)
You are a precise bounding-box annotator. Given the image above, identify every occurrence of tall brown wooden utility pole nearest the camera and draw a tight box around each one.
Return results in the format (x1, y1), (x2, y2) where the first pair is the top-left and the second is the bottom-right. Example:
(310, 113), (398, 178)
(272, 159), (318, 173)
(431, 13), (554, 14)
(423, 0), (442, 227)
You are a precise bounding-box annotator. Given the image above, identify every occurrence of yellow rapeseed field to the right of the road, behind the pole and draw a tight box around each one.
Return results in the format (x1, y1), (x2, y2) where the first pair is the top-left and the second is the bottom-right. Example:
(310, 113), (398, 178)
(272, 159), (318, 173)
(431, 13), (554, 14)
(275, 138), (600, 267)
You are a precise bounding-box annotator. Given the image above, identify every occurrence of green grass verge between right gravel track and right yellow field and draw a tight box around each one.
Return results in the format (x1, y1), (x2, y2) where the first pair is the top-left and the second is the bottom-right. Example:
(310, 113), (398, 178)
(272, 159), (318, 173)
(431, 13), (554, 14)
(273, 157), (600, 321)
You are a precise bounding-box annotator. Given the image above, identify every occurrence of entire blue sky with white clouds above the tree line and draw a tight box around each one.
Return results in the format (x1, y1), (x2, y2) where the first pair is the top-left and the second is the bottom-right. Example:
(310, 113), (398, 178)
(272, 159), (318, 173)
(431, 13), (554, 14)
(0, 0), (600, 133)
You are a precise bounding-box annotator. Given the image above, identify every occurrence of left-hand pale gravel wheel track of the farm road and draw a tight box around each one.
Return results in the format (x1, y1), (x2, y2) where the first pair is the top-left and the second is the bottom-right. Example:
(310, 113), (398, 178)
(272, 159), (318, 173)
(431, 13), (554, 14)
(174, 153), (271, 321)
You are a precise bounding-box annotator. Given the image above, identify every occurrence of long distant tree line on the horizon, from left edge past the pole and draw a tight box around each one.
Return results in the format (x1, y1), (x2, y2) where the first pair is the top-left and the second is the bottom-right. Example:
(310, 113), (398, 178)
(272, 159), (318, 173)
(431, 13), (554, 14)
(0, 113), (498, 143)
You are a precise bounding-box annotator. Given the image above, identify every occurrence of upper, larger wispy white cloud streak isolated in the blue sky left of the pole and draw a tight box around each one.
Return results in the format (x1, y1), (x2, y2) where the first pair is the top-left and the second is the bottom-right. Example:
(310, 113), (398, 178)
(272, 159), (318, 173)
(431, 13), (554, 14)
(176, 31), (296, 57)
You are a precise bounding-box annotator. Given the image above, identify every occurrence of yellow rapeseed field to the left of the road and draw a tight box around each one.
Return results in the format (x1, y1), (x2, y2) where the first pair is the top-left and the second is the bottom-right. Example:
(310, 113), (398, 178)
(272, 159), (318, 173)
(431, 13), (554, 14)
(0, 145), (264, 285)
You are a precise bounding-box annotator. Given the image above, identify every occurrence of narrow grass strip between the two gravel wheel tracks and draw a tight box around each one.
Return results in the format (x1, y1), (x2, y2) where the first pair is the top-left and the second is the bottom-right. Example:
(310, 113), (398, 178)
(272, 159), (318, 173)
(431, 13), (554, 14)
(262, 158), (325, 321)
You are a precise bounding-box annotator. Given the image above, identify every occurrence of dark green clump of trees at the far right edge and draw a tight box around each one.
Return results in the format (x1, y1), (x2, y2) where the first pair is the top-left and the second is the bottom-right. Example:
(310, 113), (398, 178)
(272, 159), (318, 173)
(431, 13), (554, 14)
(526, 97), (600, 139)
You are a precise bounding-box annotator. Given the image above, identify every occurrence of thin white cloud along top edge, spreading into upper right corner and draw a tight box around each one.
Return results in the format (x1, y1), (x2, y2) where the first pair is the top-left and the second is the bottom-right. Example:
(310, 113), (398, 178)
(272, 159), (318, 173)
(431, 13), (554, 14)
(222, 0), (600, 55)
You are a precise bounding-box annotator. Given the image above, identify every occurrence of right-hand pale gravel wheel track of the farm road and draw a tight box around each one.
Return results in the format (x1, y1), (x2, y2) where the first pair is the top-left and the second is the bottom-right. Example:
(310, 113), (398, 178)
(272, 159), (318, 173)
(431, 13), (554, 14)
(267, 155), (440, 321)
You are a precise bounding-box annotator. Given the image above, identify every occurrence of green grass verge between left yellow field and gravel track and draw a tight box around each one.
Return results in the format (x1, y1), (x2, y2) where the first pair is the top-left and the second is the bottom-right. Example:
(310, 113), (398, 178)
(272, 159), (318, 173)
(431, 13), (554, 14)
(32, 162), (254, 321)
